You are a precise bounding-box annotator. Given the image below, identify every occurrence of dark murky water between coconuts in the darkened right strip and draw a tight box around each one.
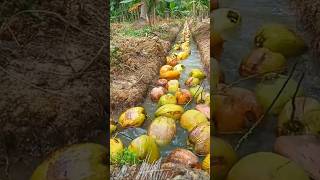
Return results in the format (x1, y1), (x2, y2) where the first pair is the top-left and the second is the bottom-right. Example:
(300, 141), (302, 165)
(219, 0), (320, 155)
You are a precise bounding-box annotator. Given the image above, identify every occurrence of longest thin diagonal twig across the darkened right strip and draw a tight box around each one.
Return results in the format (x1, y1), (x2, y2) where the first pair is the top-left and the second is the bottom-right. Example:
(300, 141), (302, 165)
(235, 62), (298, 151)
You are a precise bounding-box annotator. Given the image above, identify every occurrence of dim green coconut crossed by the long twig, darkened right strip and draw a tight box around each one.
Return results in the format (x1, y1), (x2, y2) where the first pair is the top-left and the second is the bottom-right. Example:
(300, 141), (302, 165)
(255, 75), (303, 114)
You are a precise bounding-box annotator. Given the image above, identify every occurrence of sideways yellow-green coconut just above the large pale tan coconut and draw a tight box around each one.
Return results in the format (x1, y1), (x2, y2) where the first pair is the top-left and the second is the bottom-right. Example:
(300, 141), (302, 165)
(155, 104), (184, 120)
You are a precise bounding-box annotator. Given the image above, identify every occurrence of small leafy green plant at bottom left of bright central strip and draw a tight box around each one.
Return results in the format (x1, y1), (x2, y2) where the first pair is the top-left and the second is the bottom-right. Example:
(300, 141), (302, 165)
(115, 148), (142, 166)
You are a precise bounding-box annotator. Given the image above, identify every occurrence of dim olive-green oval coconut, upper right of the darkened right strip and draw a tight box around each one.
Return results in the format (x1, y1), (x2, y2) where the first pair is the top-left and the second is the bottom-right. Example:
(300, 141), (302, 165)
(254, 24), (306, 57)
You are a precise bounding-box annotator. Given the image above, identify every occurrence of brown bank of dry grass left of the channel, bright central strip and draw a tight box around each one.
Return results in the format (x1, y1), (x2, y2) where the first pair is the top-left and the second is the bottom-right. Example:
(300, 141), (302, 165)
(110, 23), (182, 113)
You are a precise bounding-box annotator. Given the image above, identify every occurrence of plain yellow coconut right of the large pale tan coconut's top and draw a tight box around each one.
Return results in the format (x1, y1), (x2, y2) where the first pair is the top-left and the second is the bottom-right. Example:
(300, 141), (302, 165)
(180, 109), (208, 132)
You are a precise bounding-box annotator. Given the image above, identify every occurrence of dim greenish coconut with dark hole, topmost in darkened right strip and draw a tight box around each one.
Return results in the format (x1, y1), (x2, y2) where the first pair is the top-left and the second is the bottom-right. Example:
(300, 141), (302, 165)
(211, 8), (241, 33)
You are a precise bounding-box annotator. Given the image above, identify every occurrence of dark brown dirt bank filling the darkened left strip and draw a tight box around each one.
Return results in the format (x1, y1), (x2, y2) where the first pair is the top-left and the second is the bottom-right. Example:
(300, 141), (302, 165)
(0, 0), (108, 179)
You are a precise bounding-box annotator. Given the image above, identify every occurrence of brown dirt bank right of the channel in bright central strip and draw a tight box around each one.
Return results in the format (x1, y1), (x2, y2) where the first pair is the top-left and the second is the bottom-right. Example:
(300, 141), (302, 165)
(191, 21), (210, 74)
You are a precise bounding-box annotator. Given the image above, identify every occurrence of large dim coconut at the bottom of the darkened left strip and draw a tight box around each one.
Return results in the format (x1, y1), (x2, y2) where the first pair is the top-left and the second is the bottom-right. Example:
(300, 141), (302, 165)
(30, 143), (109, 180)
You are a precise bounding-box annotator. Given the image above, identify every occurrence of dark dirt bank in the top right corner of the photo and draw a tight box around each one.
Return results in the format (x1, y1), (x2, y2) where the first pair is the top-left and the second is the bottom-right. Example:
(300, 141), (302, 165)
(292, 0), (320, 57)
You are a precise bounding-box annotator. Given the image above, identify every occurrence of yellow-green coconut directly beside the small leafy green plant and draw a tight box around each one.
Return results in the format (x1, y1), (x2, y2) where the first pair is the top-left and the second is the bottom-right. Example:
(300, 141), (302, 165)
(128, 135), (160, 163)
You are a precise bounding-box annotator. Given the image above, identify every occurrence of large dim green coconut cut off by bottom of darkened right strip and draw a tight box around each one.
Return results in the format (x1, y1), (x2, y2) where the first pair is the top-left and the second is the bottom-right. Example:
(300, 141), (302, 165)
(227, 152), (309, 180)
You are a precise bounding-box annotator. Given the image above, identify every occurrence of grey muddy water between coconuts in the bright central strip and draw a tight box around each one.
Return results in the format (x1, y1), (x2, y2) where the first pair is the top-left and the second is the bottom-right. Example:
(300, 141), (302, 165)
(118, 29), (210, 157)
